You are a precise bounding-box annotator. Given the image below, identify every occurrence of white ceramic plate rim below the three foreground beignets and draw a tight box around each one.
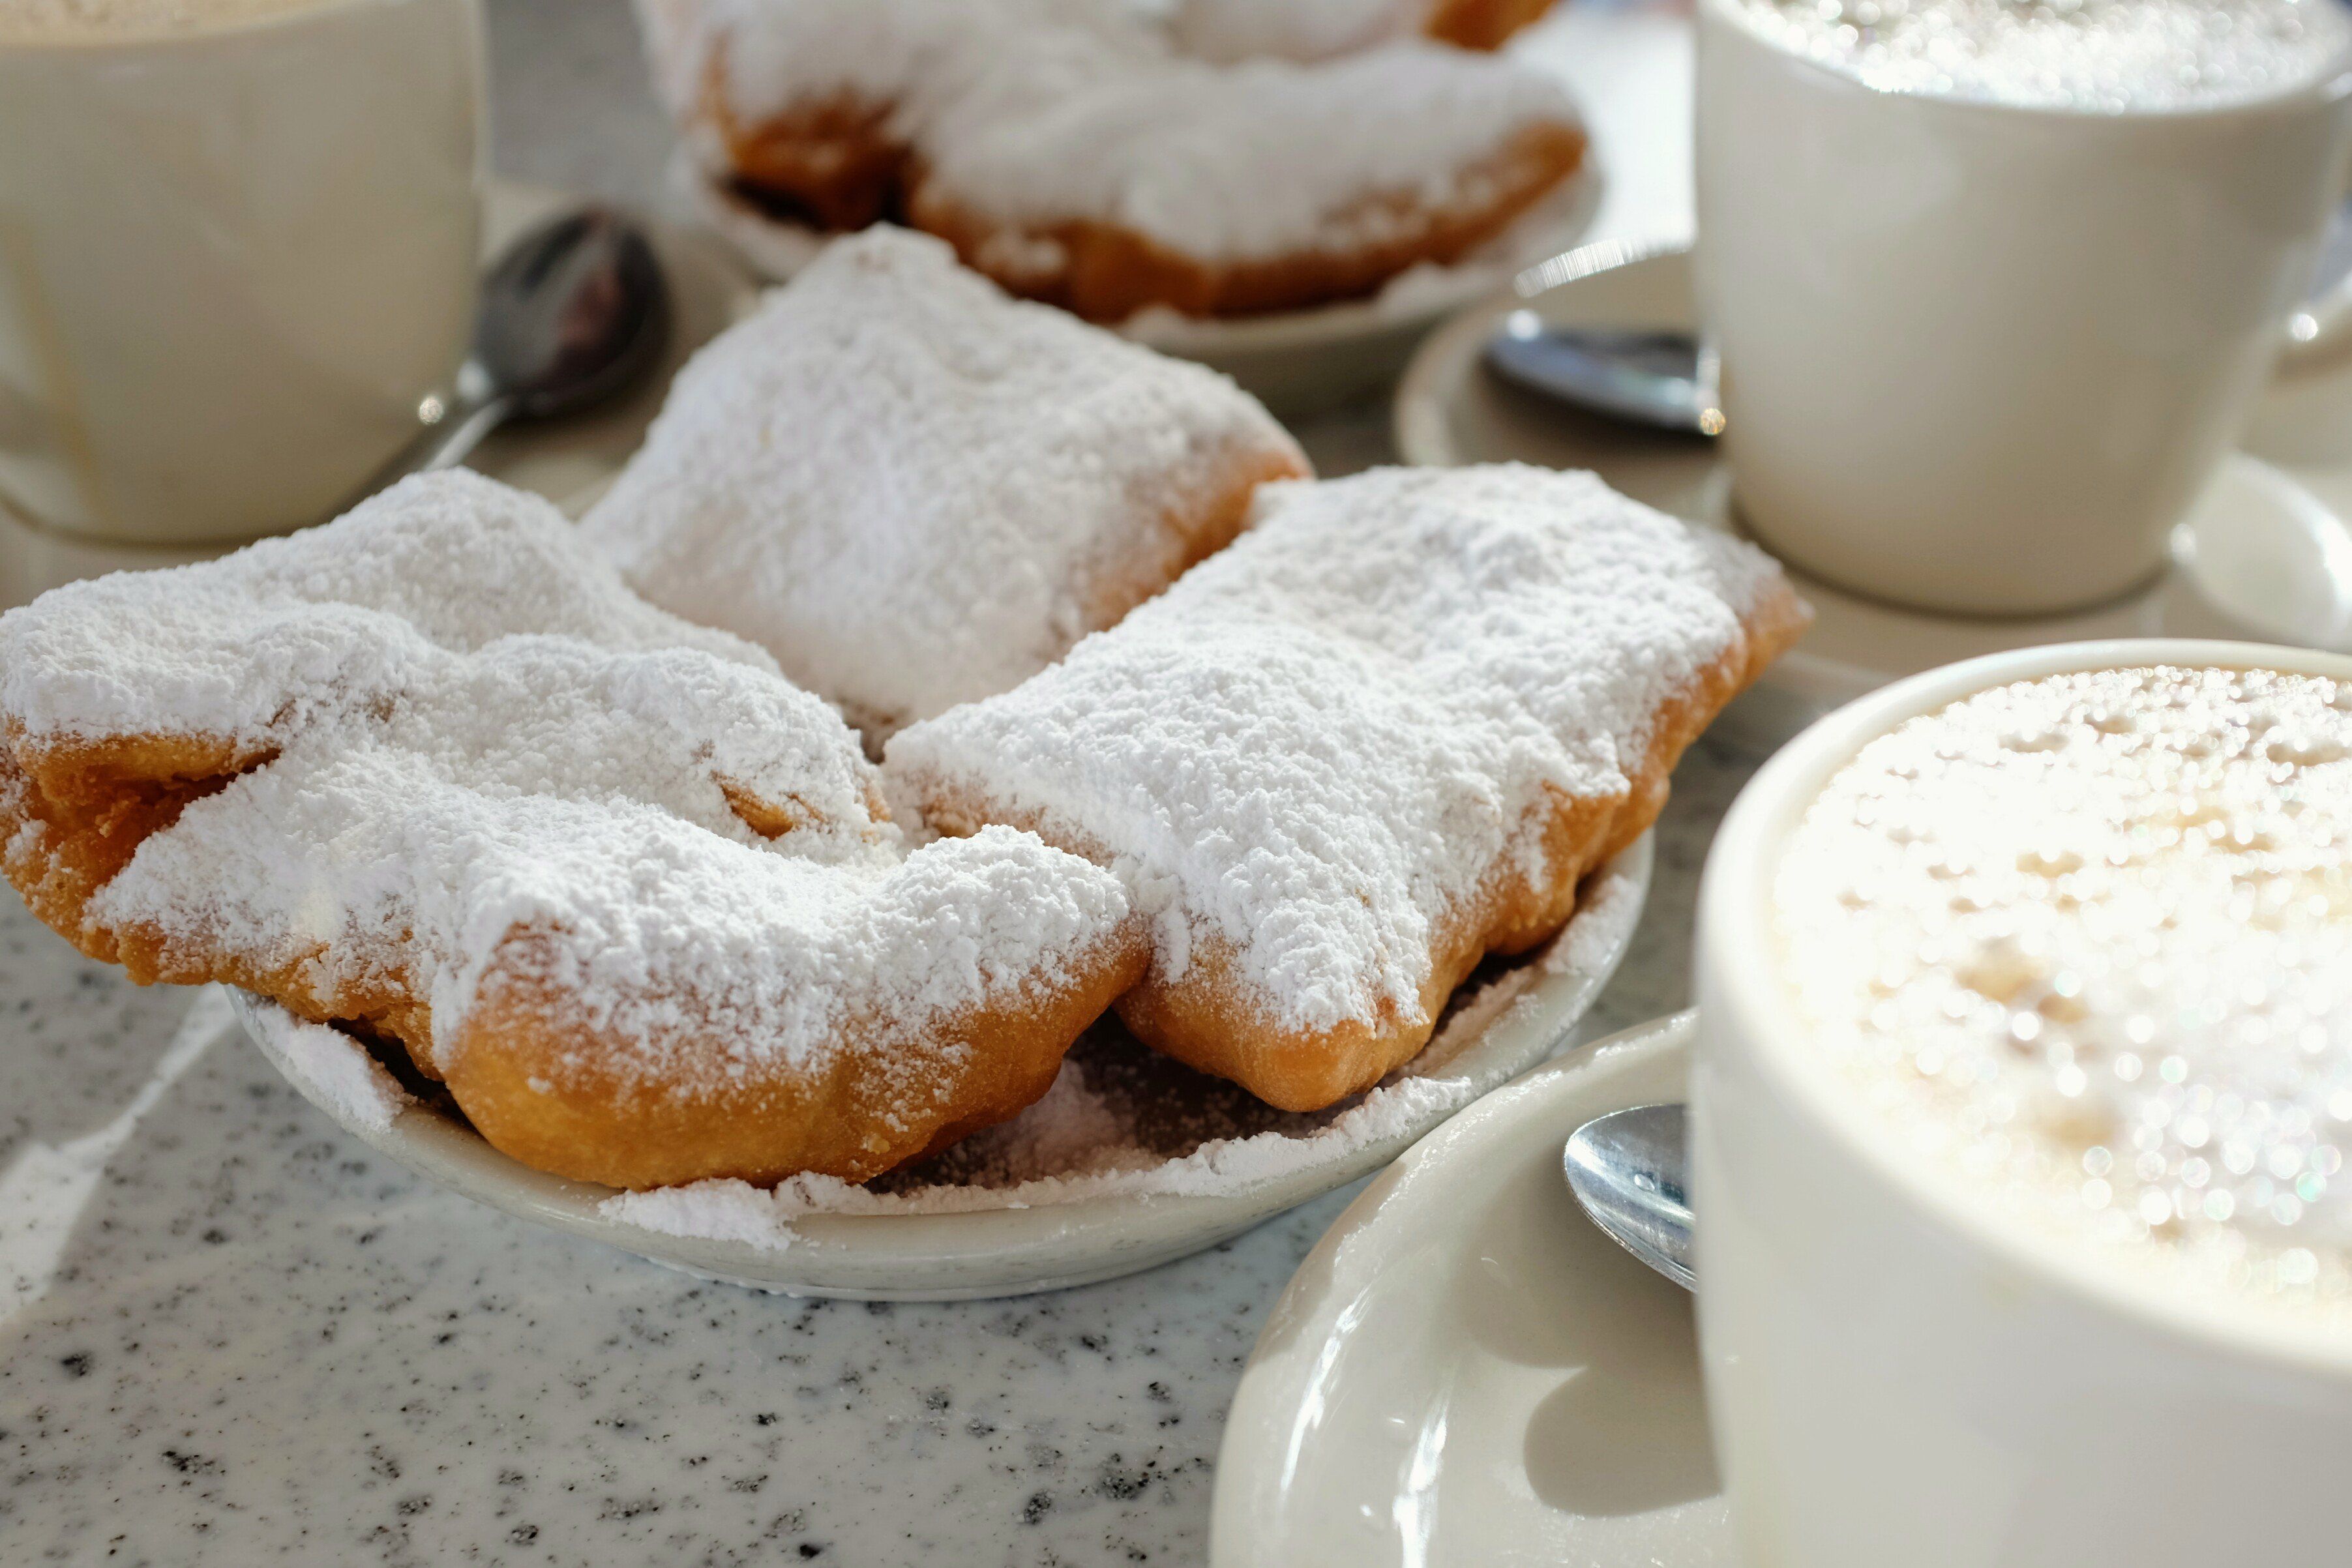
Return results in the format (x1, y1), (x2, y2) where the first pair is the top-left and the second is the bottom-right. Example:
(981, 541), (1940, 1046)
(233, 835), (1651, 1300)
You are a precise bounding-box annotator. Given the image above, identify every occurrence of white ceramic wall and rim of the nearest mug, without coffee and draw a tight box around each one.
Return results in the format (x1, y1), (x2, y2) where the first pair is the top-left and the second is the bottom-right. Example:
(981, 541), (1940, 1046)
(1691, 642), (2352, 1568)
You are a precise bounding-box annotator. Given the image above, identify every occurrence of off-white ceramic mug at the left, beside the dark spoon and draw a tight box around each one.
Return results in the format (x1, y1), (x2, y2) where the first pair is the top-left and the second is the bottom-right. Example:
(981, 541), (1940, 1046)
(0, 0), (484, 546)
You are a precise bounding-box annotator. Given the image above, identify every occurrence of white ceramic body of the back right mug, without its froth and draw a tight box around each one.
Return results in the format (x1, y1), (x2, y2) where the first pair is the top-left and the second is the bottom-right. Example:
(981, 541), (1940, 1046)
(1696, 0), (2352, 614)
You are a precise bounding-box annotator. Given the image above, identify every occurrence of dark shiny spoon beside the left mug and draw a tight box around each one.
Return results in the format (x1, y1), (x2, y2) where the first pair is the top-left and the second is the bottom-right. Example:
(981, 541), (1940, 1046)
(411, 207), (670, 473)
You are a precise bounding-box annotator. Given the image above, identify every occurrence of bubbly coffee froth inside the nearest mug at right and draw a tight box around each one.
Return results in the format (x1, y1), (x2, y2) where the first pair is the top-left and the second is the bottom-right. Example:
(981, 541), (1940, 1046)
(1774, 668), (2352, 1324)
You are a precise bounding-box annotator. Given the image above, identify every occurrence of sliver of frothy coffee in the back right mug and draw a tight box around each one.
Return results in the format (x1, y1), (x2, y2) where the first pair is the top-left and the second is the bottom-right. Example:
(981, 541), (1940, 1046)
(1717, 0), (2352, 113)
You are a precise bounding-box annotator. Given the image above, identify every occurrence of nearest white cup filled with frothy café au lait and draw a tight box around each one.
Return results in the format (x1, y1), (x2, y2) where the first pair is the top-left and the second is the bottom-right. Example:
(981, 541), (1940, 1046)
(1693, 642), (2352, 1568)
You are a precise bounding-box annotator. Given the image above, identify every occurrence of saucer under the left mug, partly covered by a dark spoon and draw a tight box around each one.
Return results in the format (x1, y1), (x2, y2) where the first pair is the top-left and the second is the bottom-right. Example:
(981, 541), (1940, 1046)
(0, 181), (760, 609)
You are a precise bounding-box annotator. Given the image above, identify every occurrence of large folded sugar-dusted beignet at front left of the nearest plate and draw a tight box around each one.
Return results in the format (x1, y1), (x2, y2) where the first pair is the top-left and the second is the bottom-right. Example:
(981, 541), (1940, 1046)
(0, 475), (1140, 1187)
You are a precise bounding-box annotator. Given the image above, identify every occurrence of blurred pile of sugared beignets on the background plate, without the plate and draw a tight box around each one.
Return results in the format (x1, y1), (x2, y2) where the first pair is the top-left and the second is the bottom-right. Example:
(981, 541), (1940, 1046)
(647, 0), (1585, 322)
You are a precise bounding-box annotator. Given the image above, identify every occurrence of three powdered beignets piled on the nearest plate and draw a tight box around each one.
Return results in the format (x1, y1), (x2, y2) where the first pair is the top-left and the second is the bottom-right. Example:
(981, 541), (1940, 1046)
(0, 235), (1804, 1187)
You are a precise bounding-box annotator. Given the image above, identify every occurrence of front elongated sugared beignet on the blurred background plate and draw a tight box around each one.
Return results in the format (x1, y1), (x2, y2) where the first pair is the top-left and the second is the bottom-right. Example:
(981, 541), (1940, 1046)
(908, 42), (1585, 322)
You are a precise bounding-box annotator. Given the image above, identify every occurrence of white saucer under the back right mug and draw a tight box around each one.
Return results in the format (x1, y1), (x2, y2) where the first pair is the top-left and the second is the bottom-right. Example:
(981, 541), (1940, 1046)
(1395, 242), (2352, 729)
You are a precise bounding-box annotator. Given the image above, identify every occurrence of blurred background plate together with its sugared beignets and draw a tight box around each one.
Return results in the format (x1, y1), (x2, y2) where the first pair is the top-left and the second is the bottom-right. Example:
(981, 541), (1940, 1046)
(640, 0), (1597, 411)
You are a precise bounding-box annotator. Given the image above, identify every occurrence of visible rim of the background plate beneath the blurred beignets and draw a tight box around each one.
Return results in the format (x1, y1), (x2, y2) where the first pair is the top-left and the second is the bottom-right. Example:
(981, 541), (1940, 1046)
(670, 153), (1601, 419)
